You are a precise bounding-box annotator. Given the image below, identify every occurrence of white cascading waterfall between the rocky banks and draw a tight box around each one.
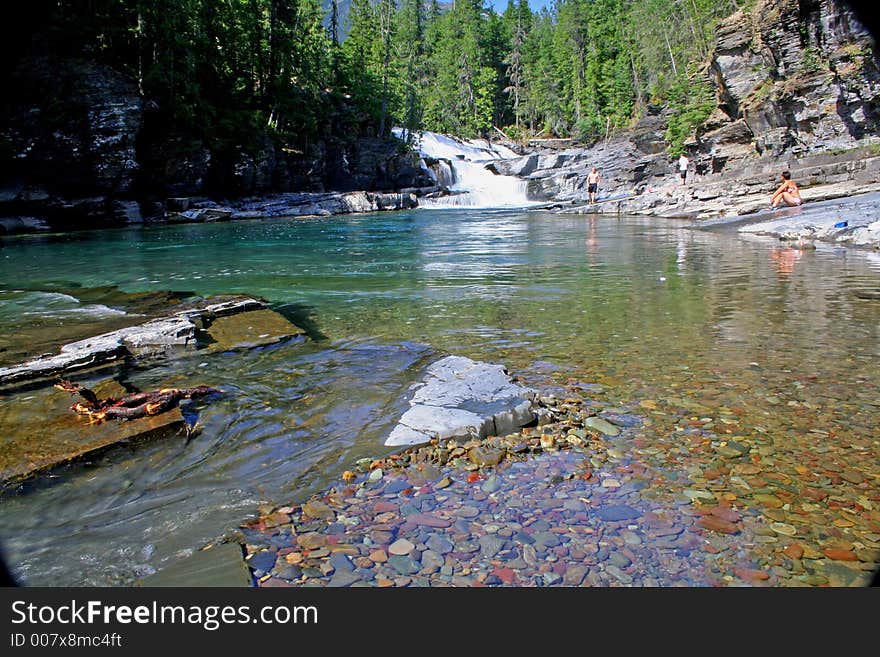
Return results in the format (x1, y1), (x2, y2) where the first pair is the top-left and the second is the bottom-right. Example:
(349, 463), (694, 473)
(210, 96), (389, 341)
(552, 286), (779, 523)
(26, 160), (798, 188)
(394, 128), (533, 208)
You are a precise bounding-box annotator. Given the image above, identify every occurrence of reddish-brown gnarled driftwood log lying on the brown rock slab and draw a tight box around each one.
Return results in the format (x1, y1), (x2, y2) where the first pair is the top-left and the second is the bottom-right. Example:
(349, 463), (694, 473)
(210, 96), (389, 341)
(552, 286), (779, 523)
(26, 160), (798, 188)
(55, 380), (223, 422)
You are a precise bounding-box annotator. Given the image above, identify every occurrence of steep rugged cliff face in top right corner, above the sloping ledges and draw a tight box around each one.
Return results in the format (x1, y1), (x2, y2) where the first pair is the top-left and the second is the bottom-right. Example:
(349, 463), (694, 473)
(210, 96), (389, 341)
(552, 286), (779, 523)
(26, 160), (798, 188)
(691, 0), (880, 171)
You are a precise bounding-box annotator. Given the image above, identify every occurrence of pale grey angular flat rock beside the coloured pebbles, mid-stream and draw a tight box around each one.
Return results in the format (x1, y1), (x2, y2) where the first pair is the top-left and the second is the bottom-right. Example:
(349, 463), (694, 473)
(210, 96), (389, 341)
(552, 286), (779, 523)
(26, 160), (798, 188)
(385, 356), (535, 446)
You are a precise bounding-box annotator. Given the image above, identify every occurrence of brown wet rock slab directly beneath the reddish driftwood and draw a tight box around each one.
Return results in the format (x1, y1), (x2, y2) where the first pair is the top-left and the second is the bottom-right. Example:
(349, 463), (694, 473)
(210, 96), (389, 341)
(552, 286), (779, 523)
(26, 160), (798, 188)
(0, 384), (184, 486)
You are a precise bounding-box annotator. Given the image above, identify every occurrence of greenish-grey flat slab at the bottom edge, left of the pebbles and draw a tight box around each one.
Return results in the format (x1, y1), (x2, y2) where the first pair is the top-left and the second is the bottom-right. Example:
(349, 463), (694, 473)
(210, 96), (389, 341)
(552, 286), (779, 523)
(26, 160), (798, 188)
(138, 543), (253, 588)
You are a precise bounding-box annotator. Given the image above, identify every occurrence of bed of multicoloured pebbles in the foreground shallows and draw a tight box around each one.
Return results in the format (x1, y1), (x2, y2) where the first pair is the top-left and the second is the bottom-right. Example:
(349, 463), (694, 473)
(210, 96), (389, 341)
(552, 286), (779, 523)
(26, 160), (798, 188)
(242, 381), (880, 587)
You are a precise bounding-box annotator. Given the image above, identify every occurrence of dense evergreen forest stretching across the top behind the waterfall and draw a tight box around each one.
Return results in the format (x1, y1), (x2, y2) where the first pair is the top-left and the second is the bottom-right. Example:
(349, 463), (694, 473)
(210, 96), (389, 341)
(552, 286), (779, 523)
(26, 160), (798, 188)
(4, 0), (736, 153)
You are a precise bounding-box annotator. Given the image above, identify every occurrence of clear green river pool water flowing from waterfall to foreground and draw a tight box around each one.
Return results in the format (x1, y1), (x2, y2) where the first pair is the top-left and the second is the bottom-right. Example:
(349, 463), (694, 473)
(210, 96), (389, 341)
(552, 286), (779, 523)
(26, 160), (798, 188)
(0, 210), (880, 585)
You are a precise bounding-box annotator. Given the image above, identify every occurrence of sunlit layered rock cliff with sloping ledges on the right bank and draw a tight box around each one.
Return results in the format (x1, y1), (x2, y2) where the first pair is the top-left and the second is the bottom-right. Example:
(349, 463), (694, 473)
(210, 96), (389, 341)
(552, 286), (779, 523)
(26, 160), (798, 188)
(493, 0), (880, 223)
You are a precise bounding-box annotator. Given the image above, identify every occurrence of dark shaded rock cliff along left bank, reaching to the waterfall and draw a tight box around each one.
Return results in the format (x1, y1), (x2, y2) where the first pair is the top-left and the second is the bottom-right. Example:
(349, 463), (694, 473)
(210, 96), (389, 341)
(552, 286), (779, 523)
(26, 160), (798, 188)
(0, 58), (433, 233)
